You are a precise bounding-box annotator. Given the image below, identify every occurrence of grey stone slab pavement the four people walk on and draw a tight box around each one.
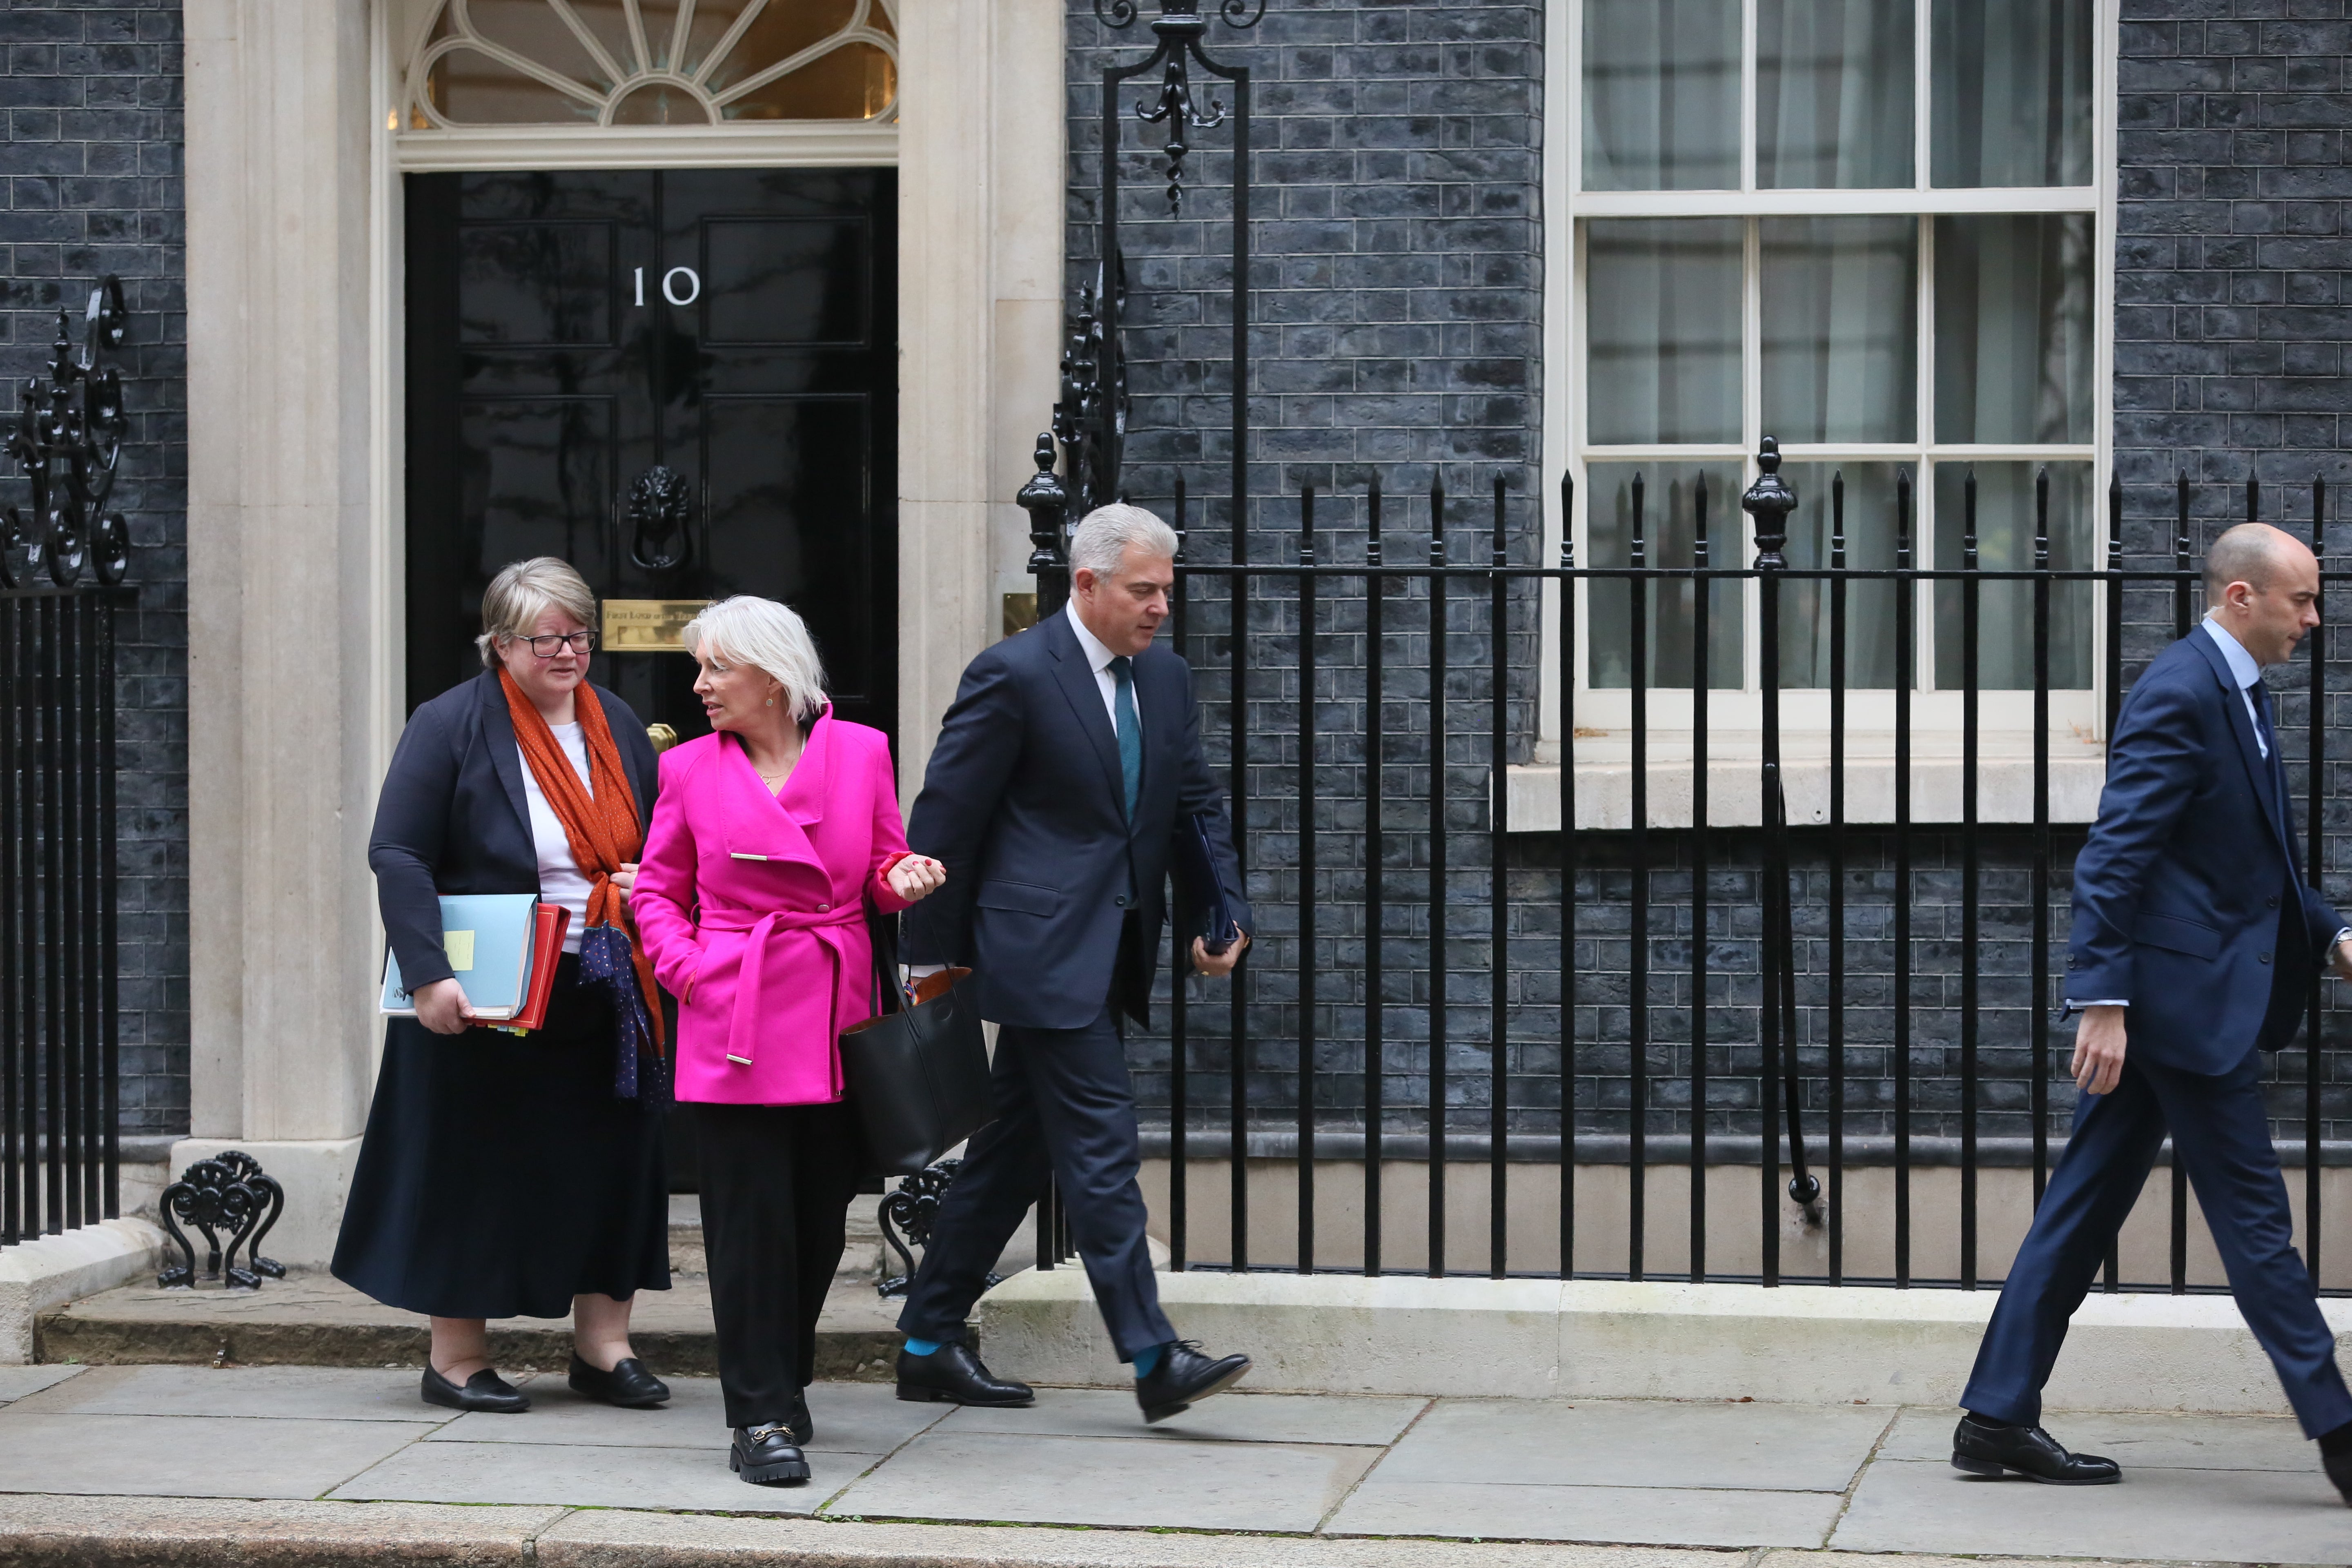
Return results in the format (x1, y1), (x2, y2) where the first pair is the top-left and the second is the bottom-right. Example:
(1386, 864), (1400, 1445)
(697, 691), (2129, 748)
(0, 1366), (2352, 1568)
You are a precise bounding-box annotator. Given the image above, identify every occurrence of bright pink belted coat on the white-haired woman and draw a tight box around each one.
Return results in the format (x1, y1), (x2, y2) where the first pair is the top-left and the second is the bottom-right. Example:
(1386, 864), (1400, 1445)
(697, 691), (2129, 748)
(628, 708), (906, 1105)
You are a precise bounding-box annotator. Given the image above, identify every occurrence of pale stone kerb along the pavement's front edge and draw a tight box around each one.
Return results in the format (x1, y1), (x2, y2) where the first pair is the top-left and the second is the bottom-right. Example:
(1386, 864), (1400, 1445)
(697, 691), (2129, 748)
(0, 1495), (2119, 1568)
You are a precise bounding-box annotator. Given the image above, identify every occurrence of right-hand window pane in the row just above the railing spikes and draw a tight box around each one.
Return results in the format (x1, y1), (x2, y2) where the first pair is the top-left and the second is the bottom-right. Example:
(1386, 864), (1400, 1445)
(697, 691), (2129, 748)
(1936, 212), (2093, 444)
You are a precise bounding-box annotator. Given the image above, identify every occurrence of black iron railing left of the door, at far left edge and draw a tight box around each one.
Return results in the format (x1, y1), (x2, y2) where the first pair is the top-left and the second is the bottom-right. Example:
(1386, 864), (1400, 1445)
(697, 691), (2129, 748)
(0, 588), (134, 1246)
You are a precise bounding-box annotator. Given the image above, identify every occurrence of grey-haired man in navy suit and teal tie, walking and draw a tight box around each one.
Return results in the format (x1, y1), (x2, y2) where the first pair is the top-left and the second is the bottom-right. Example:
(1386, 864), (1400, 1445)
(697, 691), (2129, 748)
(898, 506), (1249, 1422)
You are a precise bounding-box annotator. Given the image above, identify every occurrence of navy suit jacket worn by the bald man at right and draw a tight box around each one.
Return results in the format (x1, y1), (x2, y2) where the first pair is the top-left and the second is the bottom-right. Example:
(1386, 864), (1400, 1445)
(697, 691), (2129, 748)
(2065, 628), (2343, 1072)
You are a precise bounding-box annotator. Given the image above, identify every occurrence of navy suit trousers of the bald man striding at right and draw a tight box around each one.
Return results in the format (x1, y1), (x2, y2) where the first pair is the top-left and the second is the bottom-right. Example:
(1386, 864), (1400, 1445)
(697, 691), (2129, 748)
(1959, 1051), (2352, 1437)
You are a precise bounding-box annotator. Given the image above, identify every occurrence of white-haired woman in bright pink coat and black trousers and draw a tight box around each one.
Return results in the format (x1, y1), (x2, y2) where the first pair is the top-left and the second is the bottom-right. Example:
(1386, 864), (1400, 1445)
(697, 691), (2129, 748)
(630, 595), (946, 1486)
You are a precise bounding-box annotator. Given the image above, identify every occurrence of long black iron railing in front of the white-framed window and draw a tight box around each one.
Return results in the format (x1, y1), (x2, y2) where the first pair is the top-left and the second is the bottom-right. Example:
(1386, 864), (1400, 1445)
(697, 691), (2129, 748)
(1030, 444), (2352, 1293)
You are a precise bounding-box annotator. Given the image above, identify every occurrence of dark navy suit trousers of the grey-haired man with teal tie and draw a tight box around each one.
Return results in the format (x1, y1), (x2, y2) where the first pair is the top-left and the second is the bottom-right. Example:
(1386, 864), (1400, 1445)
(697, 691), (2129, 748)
(898, 1006), (1176, 1361)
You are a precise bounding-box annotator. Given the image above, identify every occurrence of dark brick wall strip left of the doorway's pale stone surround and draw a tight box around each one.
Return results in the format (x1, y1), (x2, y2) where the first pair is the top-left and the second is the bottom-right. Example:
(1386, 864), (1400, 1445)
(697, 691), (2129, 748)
(0, 0), (188, 1133)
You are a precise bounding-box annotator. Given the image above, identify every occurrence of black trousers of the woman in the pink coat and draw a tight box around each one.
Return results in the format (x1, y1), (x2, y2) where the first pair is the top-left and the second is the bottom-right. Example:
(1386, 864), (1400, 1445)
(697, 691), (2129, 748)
(694, 1105), (858, 1427)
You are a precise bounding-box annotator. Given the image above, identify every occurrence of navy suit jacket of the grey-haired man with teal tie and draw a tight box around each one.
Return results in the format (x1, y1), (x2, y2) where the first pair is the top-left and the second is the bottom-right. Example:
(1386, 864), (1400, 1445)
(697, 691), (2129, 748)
(903, 611), (1249, 1030)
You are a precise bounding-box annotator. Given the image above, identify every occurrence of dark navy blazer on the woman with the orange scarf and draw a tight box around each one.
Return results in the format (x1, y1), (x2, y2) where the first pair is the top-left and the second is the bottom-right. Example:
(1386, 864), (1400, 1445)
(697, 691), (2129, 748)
(367, 670), (656, 990)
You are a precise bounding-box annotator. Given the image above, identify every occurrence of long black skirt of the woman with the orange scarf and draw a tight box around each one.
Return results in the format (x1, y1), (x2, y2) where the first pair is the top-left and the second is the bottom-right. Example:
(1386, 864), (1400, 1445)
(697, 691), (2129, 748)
(334, 954), (670, 1319)
